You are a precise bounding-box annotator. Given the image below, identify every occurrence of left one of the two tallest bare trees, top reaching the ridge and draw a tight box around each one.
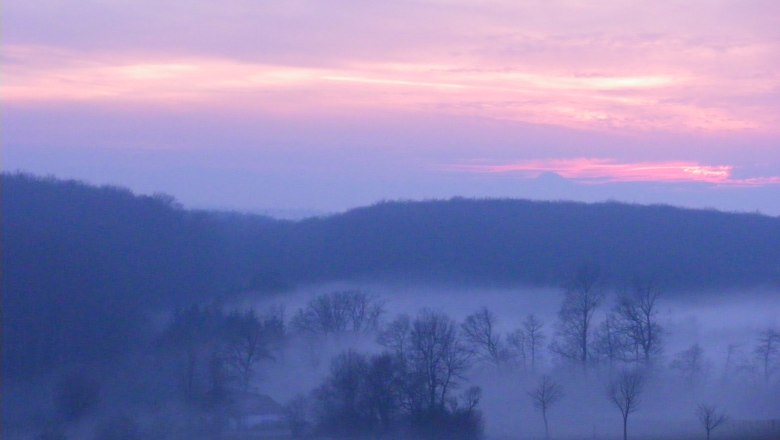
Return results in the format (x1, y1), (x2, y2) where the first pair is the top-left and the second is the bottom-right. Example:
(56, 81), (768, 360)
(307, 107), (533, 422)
(550, 265), (604, 365)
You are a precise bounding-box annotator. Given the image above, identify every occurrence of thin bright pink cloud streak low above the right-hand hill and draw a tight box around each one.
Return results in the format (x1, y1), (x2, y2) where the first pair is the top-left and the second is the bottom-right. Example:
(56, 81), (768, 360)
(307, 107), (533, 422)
(444, 158), (780, 186)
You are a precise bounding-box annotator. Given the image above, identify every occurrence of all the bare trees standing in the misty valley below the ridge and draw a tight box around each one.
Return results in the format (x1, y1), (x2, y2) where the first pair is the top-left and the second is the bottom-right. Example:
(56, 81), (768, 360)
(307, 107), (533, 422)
(25, 286), (780, 440)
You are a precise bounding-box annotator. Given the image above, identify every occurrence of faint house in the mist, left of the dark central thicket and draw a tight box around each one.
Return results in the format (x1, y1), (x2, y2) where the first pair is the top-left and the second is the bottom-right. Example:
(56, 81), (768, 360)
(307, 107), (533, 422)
(230, 392), (291, 440)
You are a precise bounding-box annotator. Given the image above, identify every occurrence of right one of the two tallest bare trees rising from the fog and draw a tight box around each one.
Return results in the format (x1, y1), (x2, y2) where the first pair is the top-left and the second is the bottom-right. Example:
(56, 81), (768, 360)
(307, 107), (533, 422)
(615, 278), (662, 364)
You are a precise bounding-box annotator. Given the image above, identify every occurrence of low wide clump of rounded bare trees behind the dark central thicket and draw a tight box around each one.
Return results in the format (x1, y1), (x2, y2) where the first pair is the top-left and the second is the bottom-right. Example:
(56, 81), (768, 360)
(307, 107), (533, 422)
(292, 290), (384, 334)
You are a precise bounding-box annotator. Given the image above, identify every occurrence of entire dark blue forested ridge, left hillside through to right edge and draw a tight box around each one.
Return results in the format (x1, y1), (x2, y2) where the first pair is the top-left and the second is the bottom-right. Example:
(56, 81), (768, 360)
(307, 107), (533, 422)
(2, 173), (780, 378)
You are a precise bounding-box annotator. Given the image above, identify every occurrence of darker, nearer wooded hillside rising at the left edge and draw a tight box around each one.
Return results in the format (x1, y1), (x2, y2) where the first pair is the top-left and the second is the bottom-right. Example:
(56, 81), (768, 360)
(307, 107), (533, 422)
(2, 175), (226, 375)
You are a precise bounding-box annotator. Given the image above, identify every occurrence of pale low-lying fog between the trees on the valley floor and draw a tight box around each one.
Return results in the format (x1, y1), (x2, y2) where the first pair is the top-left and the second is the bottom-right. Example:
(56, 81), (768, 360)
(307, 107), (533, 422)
(236, 282), (780, 439)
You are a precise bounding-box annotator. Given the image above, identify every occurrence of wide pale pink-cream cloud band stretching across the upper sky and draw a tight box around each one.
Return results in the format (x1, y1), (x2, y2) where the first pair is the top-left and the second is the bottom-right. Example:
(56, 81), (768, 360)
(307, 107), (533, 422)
(0, 46), (778, 132)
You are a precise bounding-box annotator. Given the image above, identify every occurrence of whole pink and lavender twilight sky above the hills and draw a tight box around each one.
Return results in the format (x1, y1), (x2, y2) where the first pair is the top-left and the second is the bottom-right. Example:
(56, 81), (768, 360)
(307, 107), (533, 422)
(0, 0), (780, 216)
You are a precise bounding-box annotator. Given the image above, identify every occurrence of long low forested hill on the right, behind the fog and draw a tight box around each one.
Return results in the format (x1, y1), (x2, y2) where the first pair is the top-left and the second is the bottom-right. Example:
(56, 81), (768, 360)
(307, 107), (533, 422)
(258, 198), (780, 289)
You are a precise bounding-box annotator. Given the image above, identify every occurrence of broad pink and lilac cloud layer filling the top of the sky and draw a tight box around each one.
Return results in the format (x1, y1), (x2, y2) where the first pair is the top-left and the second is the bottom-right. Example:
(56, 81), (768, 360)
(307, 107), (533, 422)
(0, 0), (780, 135)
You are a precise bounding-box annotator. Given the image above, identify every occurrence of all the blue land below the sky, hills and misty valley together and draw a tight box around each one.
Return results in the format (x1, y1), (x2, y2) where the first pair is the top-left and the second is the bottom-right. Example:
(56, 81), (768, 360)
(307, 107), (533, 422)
(3, 174), (780, 439)
